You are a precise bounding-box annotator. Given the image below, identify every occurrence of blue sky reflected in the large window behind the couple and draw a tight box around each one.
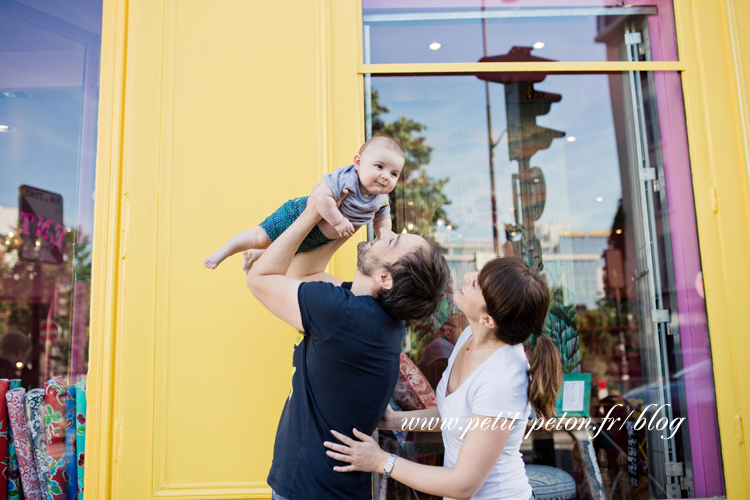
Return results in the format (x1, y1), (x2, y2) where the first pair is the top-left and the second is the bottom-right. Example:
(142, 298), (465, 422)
(372, 74), (621, 241)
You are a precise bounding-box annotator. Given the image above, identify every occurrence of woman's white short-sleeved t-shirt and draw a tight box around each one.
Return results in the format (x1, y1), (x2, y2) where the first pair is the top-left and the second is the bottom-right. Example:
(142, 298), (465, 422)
(436, 327), (531, 500)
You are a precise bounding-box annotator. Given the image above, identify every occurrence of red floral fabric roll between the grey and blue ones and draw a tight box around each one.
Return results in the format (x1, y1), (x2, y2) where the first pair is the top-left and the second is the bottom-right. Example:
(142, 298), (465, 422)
(44, 377), (68, 500)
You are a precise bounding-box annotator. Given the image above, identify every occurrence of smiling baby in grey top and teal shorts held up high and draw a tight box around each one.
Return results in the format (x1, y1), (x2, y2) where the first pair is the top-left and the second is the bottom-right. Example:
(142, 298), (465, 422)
(203, 135), (406, 269)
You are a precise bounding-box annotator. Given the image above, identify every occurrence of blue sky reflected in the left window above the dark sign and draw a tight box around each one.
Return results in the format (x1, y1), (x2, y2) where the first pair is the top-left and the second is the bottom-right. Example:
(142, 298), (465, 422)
(0, 7), (101, 232)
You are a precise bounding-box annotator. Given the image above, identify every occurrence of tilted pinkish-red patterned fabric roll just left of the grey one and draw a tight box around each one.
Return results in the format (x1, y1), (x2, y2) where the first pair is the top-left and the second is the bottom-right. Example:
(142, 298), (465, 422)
(5, 389), (45, 500)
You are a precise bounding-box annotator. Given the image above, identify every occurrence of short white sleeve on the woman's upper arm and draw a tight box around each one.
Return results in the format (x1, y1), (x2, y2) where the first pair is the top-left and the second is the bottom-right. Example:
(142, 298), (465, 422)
(469, 363), (529, 419)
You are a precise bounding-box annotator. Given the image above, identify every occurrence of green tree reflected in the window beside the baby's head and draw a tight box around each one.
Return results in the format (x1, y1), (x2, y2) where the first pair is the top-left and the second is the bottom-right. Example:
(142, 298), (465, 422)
(372, 89), (451, 243)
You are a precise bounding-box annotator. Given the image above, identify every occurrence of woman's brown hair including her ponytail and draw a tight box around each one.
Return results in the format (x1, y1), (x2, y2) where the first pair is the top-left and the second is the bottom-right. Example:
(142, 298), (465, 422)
(478, 257), (562, 419)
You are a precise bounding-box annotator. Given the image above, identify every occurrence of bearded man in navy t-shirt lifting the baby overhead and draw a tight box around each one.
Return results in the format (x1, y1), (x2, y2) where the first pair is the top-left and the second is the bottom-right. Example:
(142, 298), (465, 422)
(247, 194), (450, 500)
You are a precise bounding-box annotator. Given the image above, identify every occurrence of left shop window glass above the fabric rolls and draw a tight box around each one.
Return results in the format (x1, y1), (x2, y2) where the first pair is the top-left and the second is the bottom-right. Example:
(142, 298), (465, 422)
(0, 0), (102, 390)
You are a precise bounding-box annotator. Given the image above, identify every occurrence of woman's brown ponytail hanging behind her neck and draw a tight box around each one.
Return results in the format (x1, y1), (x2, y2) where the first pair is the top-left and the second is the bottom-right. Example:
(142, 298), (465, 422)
(529, 333), (562, 420)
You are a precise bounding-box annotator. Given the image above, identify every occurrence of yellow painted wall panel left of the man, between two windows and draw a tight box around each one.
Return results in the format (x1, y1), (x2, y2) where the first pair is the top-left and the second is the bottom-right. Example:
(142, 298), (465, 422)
(87, 0), (362, 500)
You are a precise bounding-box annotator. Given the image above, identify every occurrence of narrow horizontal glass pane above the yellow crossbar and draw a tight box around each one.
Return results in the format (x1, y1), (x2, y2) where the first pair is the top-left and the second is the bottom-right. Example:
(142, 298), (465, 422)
(362, 0), (677, 64)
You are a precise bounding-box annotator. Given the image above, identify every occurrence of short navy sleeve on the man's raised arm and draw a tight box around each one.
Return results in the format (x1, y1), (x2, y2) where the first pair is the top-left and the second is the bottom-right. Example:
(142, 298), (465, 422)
(297, 281), (351, 342)
